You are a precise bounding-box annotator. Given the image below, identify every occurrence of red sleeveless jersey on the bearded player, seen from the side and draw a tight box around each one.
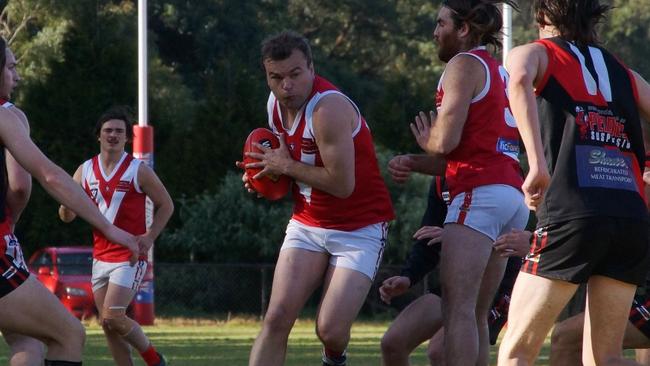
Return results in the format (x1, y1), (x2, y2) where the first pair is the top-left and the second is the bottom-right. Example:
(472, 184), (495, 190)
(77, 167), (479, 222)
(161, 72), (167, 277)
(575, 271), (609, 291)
(436, 46), (523, 198)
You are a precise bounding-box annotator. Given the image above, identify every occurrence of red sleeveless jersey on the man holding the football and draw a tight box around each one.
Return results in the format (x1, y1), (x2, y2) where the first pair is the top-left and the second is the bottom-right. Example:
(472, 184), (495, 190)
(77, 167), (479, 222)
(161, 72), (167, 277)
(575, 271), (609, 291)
(267, 76), (394, 231)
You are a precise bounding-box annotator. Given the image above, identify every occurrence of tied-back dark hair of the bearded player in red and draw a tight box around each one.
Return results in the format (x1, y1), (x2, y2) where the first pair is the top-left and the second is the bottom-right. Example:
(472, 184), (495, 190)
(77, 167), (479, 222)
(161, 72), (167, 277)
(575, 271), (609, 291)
(442, 0), (519, 48)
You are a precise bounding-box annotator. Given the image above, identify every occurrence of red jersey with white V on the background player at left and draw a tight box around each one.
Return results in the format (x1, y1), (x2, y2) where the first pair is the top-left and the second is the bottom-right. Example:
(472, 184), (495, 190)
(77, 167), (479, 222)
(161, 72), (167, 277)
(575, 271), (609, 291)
(81, 153), (147, 262)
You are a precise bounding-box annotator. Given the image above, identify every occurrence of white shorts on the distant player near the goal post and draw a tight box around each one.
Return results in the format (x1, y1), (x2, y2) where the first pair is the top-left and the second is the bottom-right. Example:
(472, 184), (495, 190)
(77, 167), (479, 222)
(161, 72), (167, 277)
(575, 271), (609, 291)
(91, 259), (147, 292)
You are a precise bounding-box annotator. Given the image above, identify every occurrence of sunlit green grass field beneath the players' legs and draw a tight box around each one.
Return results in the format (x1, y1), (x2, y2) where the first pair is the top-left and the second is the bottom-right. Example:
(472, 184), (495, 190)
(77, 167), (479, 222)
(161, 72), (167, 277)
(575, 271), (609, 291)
(0, 319), (636, 366)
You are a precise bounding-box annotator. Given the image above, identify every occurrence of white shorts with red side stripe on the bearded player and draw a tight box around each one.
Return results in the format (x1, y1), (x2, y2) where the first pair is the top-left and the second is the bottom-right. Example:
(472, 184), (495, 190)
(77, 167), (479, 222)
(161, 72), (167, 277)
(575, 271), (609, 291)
(445, 184), (530, 240)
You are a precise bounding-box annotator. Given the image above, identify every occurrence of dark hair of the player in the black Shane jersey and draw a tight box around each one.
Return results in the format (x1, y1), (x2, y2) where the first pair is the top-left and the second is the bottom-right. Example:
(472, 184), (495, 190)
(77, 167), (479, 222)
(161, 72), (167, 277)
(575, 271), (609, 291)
(533, 0), (611, 46)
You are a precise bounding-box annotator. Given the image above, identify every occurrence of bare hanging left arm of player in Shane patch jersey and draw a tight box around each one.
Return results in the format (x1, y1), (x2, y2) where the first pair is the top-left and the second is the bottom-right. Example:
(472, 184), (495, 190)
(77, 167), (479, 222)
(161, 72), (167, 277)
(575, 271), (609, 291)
(506, 44), (550, 210)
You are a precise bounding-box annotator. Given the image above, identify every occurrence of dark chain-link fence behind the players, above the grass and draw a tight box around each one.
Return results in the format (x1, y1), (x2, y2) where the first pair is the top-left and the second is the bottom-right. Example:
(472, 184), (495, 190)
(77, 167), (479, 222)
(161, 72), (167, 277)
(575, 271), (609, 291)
(155, 263), (584, 318)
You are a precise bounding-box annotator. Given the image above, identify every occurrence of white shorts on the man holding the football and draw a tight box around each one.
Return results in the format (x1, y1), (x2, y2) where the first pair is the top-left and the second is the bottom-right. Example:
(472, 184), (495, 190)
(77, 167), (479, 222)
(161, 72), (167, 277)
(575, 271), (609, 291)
(280, 220), (388, 281)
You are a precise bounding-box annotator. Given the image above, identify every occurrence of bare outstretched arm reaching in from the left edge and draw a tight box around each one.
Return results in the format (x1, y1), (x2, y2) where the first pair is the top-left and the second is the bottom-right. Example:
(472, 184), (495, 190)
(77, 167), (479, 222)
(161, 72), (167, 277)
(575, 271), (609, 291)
(0, 109), (137, 252)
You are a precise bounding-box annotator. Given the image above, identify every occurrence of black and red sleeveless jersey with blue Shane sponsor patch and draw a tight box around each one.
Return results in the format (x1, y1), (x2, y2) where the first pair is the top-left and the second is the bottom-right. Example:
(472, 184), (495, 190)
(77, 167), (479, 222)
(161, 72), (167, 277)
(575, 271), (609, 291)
(536, 38), (647, 226)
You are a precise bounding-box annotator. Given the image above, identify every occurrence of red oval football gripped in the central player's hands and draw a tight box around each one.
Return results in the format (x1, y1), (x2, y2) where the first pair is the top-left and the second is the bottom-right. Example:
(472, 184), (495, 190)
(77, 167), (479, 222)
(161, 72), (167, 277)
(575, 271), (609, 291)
(243, 128), (291, 201)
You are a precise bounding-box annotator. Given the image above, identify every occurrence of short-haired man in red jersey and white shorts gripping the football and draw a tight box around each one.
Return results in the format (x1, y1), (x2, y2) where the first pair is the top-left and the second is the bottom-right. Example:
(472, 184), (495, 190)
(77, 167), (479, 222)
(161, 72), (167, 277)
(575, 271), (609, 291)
(237, 31), (394, 366)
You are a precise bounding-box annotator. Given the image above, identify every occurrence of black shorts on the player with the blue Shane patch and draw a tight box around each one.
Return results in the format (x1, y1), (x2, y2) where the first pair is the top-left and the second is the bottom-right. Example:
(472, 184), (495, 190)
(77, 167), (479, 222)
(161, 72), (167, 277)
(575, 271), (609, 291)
(521, 217), (650, 285)
